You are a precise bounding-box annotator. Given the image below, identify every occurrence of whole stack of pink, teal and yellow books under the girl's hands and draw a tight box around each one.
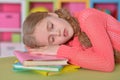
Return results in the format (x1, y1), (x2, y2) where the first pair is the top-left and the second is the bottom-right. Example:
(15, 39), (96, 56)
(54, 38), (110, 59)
(13, 51), (80, 76)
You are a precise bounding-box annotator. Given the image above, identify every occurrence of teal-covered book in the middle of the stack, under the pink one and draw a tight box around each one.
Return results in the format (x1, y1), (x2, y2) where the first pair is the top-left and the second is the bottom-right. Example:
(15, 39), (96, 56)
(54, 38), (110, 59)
(13, 62), (63, 72)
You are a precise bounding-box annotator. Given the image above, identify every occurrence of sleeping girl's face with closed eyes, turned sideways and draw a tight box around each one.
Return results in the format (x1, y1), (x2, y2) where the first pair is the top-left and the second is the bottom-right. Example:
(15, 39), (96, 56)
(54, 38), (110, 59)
(34, 13), (74, 46)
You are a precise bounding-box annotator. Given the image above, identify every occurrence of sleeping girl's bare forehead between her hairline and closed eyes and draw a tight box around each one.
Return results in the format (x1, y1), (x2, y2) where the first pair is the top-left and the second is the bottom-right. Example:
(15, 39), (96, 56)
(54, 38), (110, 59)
(34, 19), (48, 46)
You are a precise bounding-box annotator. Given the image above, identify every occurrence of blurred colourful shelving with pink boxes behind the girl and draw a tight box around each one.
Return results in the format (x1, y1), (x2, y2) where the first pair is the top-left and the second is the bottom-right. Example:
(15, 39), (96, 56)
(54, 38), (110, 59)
(0, 0), (120, 57)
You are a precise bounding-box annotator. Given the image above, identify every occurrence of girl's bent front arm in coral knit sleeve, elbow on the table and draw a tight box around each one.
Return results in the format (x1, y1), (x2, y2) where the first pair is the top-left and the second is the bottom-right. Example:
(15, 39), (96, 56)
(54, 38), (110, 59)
(57, 15), (114, 72)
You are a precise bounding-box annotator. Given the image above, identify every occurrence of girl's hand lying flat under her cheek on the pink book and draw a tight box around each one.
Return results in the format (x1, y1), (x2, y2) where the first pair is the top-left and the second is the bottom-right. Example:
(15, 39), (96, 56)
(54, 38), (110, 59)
(27, 45), (59, 55)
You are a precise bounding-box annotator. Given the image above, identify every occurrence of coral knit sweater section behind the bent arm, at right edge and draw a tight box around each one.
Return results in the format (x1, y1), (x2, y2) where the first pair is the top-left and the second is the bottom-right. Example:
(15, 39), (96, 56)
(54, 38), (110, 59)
(107, 16), (120, 51)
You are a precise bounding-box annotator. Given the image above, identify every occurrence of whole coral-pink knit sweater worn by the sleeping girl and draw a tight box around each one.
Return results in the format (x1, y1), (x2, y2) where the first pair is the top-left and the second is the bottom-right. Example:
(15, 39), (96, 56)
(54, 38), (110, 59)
(57, 8), (120, 72)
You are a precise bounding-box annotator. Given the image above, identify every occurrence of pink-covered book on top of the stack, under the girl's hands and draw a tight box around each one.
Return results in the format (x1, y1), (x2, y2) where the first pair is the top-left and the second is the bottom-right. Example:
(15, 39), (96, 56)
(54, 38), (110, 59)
(14, 50), (68, 66)
